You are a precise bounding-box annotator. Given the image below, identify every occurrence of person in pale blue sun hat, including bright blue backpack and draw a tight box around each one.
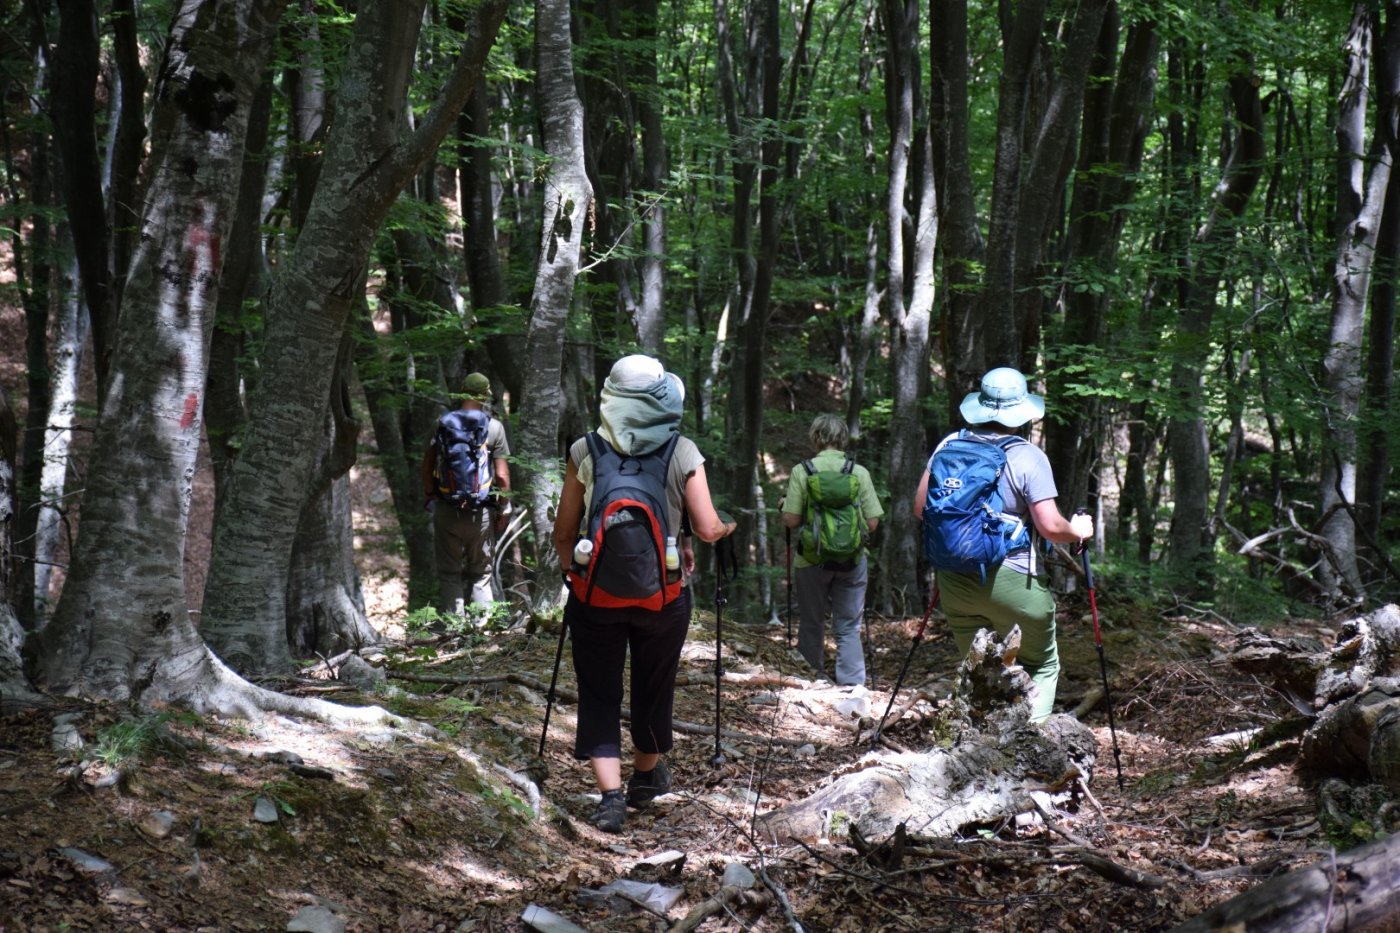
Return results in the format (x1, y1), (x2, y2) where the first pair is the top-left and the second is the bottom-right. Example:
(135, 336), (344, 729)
(914, 367), (1093, 723)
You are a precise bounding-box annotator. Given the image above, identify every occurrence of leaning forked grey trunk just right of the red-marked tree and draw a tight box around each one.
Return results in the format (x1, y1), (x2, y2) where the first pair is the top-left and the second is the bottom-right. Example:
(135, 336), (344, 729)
(194, 0), (505, 672)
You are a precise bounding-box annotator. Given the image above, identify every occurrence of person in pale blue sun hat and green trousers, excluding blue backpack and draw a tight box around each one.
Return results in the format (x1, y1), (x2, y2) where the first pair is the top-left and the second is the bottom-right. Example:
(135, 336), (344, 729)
(914, 367), (1093, 723)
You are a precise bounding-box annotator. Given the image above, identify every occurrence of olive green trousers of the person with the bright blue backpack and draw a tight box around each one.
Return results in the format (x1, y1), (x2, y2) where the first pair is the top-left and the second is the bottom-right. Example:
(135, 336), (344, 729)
(938, 566), (1060, 723)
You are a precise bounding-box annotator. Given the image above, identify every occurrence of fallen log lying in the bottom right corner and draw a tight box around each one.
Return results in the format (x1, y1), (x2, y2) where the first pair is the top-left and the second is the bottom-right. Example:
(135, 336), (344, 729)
(1173, 835), (1400, 933)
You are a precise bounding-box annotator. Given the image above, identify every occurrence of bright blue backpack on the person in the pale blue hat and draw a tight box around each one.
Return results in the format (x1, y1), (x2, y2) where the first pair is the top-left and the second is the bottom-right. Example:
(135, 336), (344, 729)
(924, 430), (1030, 583)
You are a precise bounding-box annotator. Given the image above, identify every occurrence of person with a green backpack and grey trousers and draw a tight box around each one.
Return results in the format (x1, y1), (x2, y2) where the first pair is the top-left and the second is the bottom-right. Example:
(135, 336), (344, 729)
(780, 415), (885, 686)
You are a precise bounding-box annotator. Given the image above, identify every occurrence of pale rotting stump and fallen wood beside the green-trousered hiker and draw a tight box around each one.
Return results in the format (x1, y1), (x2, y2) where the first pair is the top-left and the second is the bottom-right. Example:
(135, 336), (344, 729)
(760, 629), (1098, 842)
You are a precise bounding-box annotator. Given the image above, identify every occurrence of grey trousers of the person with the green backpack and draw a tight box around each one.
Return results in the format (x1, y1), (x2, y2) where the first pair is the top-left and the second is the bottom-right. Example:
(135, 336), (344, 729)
(792, 555), (865, 686)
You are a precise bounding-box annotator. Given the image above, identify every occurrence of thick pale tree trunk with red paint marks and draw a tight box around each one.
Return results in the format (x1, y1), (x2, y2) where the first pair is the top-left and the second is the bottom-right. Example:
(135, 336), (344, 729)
(36, 0), (292, 700)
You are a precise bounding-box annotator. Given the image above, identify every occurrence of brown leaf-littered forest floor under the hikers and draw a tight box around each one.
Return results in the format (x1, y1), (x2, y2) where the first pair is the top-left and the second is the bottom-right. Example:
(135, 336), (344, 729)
(0, 554), (1349, 932)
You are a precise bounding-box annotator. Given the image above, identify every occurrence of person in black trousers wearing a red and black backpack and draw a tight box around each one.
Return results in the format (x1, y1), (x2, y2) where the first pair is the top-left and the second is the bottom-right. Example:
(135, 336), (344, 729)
(554, 354), (736, 832)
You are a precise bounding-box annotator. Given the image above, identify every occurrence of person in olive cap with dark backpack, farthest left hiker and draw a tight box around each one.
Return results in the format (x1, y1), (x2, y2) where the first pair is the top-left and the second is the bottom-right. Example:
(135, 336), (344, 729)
(420, 373), (511, 615)
